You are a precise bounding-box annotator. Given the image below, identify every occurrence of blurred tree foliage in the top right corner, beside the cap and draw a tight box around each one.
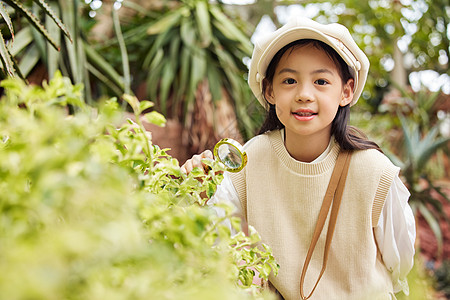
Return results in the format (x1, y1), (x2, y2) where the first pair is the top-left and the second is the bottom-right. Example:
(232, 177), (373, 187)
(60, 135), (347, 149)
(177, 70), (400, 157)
(312, 0), (450, 111)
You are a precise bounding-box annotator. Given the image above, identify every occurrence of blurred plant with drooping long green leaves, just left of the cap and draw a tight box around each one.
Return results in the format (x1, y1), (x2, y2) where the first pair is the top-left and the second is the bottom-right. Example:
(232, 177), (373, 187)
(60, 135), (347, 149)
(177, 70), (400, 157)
(104, 0), (259, 136)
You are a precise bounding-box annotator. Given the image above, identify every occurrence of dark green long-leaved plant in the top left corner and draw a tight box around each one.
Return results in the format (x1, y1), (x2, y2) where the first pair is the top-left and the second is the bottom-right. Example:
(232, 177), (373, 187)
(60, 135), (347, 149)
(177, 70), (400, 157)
(0, 0), (126, 102)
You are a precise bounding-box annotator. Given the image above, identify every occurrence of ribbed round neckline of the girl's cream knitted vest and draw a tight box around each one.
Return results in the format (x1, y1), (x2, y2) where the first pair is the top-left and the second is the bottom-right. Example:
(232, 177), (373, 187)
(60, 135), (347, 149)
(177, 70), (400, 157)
(268, 130), (340, 175)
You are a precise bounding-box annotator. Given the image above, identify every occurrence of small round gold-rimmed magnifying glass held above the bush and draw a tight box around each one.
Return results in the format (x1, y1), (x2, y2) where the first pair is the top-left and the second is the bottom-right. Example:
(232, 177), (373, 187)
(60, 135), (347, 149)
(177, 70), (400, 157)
(214, 139), (247, 173)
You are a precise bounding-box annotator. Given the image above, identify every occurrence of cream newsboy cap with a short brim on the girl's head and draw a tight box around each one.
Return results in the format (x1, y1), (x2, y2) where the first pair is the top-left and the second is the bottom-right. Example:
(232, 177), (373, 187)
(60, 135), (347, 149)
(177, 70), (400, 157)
(248, 17), (370, 107)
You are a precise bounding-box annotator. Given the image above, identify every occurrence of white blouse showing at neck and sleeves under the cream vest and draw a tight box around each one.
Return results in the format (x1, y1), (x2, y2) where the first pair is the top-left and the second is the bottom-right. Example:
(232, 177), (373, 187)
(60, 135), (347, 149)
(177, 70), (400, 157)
(208, 134), (416, 295)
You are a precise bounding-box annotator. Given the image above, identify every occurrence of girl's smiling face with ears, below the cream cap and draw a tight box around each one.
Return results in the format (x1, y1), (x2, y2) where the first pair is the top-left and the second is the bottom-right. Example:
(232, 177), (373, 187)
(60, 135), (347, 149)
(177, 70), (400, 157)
(264, 44), (353, 143)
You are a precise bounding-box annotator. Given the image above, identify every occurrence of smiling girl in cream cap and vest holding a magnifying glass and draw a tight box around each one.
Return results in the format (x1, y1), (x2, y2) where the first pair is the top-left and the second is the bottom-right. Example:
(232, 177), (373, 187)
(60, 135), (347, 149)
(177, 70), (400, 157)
(182, 18), (415, 300)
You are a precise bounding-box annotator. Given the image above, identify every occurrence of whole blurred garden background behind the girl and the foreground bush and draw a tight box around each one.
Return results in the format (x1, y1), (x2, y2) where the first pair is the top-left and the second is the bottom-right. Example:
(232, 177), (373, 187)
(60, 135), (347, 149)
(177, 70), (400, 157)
(0, 0), (450, 299)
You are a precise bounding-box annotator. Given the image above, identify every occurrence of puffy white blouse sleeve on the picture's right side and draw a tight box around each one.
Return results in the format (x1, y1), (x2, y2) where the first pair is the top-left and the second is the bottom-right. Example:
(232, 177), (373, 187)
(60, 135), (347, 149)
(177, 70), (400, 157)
(374, 176), (416, 295)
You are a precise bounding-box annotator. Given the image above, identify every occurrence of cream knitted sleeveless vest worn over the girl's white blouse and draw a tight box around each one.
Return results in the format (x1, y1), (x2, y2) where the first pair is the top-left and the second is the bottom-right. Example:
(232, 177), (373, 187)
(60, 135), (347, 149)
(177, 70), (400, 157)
(231, 130), (399, 300)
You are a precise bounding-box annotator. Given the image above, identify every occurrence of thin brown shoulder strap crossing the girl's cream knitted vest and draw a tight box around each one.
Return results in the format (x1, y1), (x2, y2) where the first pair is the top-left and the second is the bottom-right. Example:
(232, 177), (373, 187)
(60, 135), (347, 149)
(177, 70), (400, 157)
(300, 151), (351, 300)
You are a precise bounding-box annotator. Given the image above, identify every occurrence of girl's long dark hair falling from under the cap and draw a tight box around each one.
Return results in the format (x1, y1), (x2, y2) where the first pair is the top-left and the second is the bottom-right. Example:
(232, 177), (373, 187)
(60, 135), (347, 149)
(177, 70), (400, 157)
(258, 39), (382, 152)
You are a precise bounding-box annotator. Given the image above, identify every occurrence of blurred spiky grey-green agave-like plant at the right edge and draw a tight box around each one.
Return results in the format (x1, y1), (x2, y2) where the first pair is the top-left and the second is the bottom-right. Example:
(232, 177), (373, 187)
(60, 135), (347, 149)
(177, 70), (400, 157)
(376, 87), (450, 258)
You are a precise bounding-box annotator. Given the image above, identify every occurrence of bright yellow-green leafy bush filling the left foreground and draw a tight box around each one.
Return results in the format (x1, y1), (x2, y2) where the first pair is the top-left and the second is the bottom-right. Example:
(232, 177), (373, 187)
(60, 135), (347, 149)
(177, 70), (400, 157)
(0, 74), (278, 299)
